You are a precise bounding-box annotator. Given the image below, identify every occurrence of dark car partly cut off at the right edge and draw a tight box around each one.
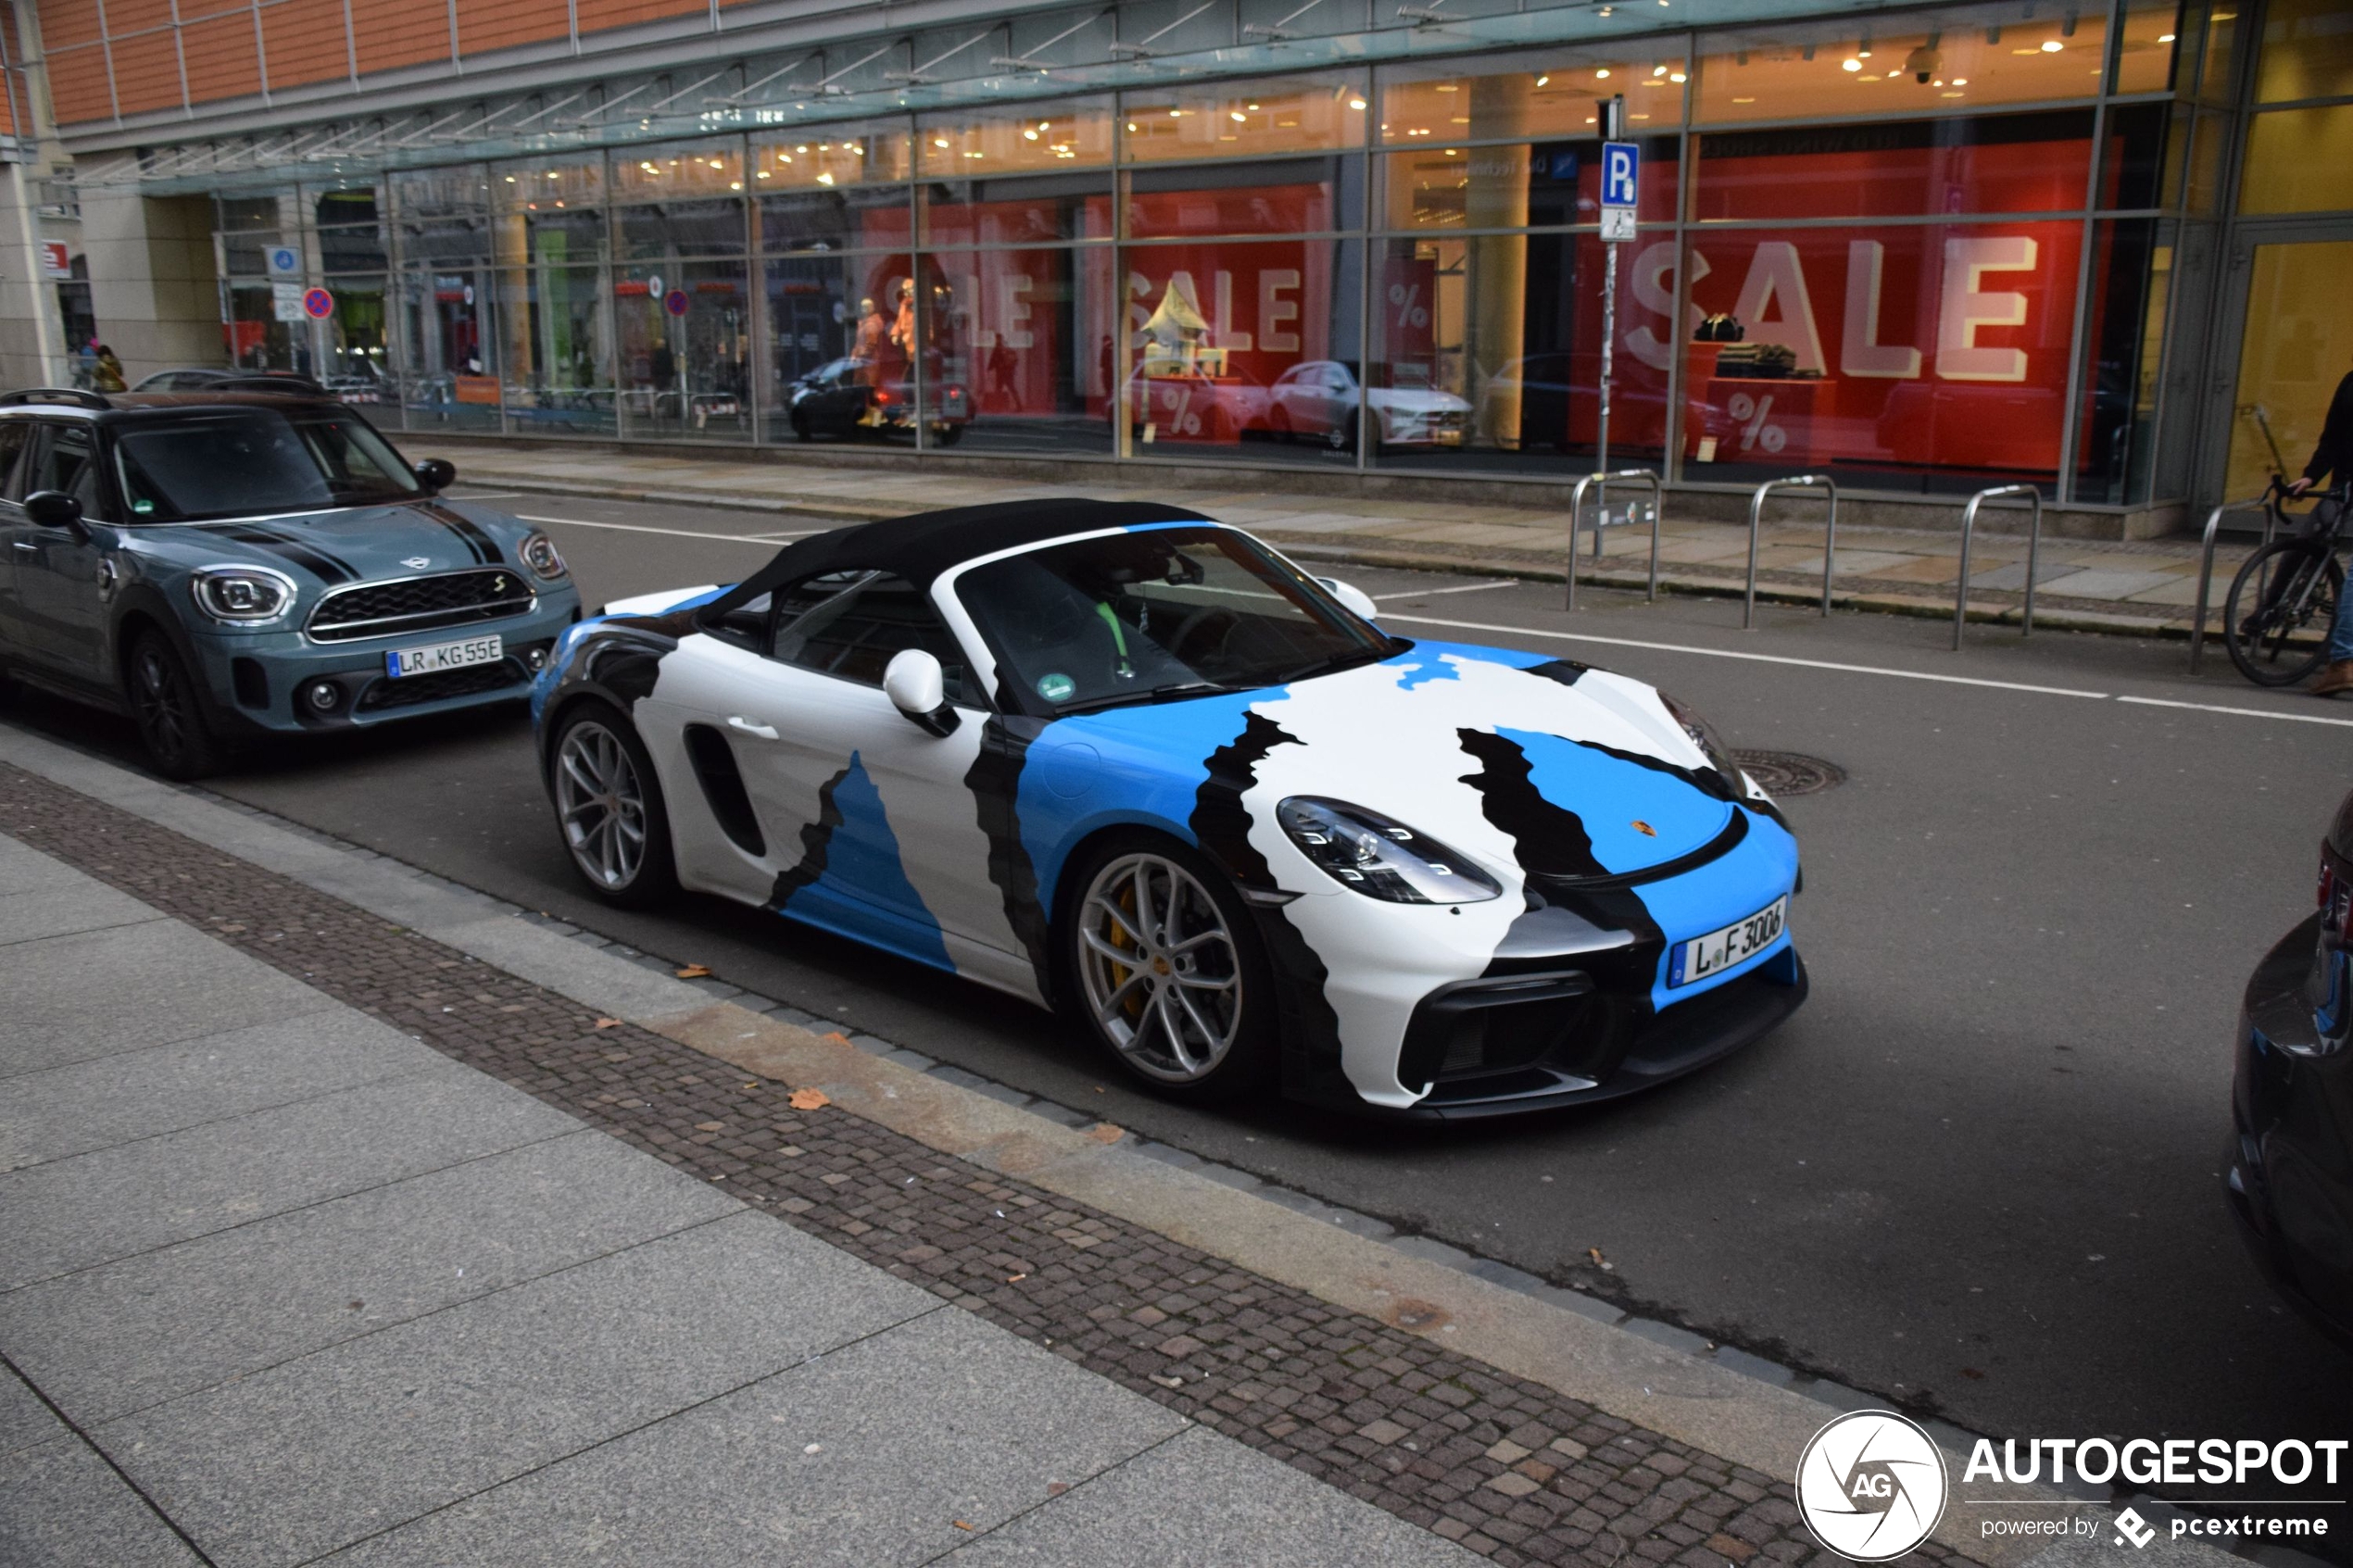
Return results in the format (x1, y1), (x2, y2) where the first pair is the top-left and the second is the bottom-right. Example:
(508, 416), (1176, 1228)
(2226, 795), (2353, 1349)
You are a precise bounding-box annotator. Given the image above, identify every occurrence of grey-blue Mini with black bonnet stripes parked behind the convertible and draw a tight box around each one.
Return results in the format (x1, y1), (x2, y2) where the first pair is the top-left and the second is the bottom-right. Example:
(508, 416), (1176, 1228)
(0, 390), (579, 778)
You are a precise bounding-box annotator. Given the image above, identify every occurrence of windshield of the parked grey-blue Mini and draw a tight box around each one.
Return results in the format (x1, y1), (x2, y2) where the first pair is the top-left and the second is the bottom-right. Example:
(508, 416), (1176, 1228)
(115, 409), (423, 521)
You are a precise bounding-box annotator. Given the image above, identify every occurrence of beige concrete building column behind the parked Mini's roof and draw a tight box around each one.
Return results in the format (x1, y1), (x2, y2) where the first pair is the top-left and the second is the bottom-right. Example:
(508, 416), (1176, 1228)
(80, 160), (226, 383)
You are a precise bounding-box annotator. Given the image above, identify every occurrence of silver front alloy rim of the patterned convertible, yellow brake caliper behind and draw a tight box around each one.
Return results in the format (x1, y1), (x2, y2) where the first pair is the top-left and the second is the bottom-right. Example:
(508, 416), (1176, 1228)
(1076, 853), (1242, 1084)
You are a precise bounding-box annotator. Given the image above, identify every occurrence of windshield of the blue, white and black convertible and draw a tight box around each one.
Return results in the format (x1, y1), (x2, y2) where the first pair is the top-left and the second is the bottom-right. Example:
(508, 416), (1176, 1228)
(955, 527), (1403, 712)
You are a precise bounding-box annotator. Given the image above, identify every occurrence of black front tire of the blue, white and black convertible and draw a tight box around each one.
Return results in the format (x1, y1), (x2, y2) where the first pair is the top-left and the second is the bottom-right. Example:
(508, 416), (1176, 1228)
(1054, 833), (1280, 1105)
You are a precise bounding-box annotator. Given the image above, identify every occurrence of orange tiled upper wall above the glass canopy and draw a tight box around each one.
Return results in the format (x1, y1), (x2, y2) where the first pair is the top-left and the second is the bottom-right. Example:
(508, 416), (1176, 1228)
(30, 0), (741, 125)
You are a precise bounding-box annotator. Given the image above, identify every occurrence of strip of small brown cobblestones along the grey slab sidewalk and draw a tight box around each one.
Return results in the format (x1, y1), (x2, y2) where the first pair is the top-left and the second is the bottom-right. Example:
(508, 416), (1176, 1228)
(0, 764), (1965, 1568)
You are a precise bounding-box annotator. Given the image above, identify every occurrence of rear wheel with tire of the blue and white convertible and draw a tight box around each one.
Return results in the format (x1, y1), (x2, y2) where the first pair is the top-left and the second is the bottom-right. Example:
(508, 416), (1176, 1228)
(548, 703), (678, 909)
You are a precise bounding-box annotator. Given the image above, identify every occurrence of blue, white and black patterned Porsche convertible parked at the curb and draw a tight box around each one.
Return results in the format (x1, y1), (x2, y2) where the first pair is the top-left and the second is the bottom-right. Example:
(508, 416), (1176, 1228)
(532, 501), (1805, 1117)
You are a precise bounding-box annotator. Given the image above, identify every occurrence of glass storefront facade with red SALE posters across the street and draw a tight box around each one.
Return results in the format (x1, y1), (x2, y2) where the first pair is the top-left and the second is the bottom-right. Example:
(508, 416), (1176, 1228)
(219, 0), (2353, 508)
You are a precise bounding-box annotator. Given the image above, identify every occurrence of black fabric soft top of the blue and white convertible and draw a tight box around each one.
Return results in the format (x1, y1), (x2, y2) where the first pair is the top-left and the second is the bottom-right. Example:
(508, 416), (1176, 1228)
(703, 501), (1216, 616)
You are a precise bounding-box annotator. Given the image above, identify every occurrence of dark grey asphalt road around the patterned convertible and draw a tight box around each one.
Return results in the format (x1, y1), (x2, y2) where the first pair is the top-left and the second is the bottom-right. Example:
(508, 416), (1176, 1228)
(19, 496), (2353, 1476)
